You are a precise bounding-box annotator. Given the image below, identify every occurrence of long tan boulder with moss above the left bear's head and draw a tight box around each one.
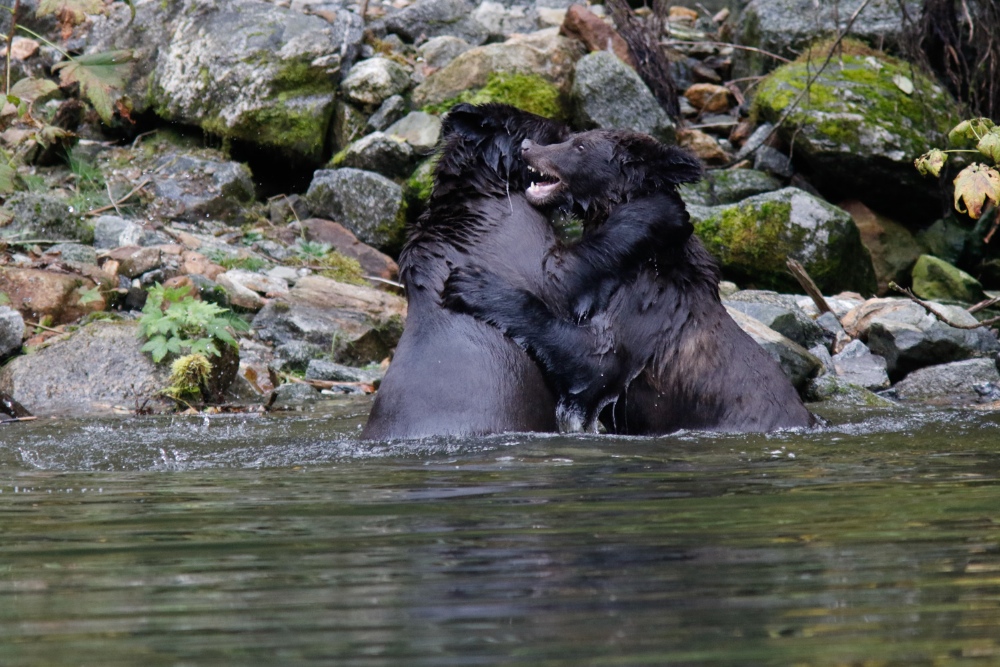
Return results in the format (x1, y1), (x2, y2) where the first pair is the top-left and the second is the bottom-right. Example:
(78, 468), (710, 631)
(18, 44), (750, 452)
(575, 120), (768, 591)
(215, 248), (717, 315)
(413, 29), (584, 107)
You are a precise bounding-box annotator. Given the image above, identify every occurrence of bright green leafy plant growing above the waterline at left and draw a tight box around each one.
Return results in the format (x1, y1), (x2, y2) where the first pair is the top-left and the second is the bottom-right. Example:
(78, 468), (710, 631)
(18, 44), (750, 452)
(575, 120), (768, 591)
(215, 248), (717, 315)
(139, 285), (249, 363)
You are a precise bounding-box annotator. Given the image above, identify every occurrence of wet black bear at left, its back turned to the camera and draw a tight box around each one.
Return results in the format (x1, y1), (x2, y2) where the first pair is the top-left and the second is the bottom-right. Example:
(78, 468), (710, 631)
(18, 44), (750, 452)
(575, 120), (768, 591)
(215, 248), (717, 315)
(361, 104), (696, 440)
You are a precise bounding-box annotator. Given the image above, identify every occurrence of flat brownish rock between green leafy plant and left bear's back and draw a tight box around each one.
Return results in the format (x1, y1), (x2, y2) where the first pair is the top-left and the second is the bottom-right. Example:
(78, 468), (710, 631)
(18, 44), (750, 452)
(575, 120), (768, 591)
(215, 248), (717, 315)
(252, 276), (406, 351)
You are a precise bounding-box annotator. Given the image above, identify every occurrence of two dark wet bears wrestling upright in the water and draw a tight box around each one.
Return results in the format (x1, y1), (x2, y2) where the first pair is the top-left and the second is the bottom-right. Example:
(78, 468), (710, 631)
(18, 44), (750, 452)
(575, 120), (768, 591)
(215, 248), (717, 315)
(362, 104), (814, 440)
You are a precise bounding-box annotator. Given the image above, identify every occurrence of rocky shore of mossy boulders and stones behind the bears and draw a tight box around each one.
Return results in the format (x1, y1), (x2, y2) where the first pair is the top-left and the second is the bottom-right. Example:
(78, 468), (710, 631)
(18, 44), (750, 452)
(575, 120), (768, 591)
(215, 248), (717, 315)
(0, 0), (1000, 417)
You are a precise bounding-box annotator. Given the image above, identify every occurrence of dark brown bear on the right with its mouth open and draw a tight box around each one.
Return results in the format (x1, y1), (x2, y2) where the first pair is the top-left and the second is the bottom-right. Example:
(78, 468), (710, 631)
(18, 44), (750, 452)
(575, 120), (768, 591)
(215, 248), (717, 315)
(444, 130), (816, 435)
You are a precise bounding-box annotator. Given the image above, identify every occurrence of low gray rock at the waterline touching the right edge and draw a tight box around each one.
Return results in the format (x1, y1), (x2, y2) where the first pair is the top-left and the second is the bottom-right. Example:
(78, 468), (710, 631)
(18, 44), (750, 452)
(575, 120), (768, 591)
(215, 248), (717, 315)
(893, 359), (1000, 403)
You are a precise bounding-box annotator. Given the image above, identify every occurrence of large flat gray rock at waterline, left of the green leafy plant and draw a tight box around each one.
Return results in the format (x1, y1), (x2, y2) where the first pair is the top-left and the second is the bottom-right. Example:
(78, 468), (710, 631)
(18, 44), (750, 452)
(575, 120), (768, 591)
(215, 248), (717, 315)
(0, 322), (170, 416)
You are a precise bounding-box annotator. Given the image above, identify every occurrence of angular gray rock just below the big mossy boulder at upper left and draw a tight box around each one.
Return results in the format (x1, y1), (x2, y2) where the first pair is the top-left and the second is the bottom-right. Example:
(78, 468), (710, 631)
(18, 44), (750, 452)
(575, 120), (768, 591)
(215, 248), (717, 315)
(150, 151), (254, 224)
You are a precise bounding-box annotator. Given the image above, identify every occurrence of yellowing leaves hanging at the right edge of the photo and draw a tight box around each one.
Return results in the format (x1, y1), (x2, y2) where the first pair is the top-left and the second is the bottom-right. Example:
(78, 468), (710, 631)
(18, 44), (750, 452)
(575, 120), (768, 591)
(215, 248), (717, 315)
(914, 118), (1000, 219)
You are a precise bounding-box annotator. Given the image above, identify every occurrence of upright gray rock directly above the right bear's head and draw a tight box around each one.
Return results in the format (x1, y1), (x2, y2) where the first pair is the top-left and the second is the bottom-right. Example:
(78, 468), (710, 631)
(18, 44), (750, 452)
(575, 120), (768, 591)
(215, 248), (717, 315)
(571, 51), (676, 143)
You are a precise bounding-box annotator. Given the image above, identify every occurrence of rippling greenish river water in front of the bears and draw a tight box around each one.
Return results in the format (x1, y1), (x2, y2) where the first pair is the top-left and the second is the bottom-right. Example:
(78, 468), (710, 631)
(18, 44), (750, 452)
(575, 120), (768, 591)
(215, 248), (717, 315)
(0, 400), (1000, 667)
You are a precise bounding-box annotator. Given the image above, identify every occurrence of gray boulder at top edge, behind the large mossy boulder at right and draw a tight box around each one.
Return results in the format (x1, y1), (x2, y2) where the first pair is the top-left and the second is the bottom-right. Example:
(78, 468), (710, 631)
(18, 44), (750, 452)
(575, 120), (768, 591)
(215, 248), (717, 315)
(739, 0), (920, 74)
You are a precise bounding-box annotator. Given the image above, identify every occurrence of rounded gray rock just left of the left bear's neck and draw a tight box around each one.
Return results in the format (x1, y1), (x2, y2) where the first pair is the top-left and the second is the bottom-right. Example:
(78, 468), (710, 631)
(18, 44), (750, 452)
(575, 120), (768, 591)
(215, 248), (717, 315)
(305, 168), (403, 250)
